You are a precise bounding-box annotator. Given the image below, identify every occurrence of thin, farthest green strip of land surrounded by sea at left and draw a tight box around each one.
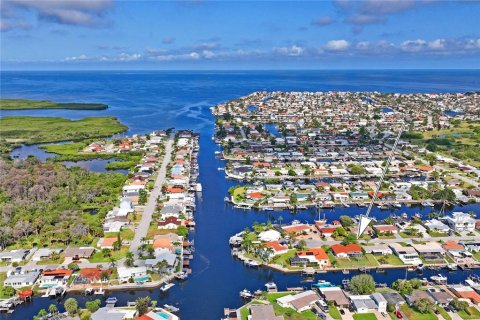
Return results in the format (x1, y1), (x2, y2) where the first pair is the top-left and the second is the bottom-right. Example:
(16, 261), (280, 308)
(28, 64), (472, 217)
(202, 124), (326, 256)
(0, 99), (108, 110)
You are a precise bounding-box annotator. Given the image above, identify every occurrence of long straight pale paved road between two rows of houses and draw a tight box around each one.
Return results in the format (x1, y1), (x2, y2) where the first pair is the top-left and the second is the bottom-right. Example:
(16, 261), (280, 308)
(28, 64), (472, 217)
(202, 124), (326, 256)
(130, 134), (173, 257)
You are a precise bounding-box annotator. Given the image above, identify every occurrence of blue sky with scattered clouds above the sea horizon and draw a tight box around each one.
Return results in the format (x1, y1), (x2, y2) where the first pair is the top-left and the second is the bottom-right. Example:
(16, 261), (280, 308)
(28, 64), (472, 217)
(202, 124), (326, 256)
(0, 0), (480, 70)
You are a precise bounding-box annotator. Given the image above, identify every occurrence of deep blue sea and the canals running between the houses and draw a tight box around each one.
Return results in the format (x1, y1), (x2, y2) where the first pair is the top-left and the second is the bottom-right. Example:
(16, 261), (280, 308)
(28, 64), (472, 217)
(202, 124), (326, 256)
(0, 71), (480, 320)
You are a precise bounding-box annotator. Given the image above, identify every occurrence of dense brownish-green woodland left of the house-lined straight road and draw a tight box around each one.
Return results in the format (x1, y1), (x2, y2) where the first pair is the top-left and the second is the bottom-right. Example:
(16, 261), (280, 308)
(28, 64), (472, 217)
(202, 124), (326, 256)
(0, 158), (126, 248)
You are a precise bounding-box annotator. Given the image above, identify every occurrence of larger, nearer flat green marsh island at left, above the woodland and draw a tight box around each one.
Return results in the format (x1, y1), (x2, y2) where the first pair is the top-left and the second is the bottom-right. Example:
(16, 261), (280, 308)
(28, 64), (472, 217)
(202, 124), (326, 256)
(0, 117), (127, 144)
